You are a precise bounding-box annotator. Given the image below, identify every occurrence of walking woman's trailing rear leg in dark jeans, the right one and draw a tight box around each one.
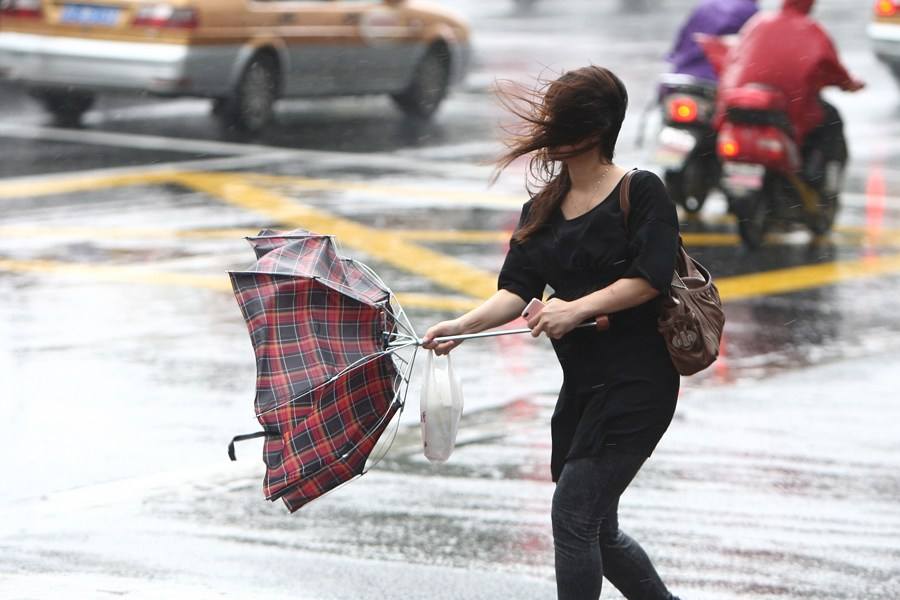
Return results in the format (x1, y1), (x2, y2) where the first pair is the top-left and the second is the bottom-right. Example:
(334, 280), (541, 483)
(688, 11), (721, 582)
(600, 499), (677, 600)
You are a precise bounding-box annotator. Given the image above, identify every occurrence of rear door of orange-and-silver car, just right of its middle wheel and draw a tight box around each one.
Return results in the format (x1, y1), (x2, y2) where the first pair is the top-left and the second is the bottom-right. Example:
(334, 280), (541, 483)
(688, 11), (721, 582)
(250, 0), (354, 96)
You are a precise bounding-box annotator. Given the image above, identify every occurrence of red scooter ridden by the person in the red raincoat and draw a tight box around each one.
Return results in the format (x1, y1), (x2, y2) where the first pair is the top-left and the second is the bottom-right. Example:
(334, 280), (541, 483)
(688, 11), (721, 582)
(717, 85), (847, 249)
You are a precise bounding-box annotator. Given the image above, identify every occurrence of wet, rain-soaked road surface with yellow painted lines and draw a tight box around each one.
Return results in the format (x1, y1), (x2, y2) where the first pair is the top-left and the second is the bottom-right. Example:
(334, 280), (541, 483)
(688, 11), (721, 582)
(0, 0), (900, 600)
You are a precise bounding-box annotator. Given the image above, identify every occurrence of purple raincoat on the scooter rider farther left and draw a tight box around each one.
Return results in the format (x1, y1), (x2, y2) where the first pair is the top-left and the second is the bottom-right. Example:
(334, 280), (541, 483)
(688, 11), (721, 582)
(666, 0), (759, 81)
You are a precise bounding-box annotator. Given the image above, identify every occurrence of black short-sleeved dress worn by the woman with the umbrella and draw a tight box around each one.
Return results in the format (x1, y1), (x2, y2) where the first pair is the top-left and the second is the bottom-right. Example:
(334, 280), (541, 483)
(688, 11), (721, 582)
(499, 171), (680, 481)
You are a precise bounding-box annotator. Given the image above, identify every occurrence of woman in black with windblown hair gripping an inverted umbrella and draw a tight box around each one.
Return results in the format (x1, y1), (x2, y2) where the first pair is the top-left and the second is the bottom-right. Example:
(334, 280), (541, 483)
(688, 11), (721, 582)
(425, 66), (679, 600)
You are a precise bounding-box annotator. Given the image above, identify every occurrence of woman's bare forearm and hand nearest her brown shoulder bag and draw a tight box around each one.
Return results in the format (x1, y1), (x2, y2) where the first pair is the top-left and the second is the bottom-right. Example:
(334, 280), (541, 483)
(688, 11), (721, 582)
(528, 277), (659, 339)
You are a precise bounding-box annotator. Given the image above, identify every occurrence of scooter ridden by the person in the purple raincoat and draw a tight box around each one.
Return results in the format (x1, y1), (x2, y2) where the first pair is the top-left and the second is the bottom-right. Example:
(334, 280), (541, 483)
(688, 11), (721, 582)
(656, 73), (721, 213)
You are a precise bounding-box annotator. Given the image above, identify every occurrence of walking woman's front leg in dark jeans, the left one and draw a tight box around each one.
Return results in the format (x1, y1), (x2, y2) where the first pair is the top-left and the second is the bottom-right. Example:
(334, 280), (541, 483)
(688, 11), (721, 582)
(552, 448), (647, 600)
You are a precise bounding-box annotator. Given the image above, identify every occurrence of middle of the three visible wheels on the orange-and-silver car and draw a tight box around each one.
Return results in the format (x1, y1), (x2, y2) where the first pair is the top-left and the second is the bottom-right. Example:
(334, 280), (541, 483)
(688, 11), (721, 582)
(213, 54), (279, 134)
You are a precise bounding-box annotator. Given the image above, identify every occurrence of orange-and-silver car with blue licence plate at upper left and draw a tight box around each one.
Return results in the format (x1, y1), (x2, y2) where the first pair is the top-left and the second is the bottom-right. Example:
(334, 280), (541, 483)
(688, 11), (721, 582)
(0, 0), (469, 132)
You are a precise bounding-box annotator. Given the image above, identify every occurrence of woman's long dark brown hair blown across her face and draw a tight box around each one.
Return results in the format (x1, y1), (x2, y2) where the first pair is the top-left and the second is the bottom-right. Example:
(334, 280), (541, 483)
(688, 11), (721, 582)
(495, 65), (628, 242)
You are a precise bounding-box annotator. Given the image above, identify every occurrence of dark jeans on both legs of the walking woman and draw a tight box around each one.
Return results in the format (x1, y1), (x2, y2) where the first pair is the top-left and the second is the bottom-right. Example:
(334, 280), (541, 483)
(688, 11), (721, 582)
(552, 448), (677, 600)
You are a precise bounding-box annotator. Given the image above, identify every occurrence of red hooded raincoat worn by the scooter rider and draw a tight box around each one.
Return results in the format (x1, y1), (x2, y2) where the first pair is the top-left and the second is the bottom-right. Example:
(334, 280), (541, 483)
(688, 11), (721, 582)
(718, 0), (854, 143)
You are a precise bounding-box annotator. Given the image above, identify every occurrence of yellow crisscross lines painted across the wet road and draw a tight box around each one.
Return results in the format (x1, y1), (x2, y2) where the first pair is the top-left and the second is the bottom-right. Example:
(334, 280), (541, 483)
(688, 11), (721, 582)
(0, 171), (900, 311)
